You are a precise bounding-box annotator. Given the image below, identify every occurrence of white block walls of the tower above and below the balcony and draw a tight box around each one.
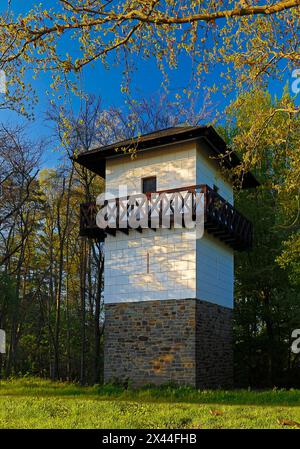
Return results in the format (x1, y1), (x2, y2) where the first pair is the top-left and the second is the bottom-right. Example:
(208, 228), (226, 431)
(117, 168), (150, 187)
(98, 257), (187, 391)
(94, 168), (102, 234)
(104, 140), (233, 307)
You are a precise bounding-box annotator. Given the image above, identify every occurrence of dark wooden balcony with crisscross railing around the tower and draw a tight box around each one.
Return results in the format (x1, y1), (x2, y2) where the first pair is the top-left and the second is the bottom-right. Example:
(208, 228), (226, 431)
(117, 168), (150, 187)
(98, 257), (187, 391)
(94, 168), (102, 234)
(80, 184), (252, 251)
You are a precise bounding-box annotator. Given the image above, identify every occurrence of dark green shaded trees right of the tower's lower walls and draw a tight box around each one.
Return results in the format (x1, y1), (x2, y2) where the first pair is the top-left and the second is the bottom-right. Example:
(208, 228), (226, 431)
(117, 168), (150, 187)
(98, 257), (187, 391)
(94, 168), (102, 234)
(234, 189), (300, 387)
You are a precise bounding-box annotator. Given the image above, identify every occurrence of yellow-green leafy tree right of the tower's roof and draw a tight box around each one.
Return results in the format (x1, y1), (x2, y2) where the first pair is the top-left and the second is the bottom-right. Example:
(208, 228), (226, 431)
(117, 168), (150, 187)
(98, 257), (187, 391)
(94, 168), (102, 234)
(228, 90), (300, 278)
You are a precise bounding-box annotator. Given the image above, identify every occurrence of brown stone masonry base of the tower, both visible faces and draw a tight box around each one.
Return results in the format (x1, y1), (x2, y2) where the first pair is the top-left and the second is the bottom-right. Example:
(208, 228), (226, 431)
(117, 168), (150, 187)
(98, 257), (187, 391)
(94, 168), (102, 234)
(104, 299), (233, 388)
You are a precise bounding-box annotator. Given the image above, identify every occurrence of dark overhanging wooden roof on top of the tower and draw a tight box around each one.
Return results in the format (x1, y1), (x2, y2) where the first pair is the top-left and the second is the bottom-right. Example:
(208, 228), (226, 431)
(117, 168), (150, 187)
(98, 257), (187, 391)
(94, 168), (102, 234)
(73, 126), (259, 188)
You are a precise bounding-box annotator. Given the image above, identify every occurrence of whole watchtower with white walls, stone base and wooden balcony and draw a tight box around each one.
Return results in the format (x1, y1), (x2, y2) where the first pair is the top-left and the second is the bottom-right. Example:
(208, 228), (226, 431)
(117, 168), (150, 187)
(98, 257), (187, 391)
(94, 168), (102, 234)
(76, 126), (258, 388)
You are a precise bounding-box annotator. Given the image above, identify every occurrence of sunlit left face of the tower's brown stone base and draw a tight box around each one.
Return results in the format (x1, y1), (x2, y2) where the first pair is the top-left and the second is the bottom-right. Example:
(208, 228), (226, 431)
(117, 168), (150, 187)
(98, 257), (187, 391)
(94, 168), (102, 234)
(104, 300), (196, 385)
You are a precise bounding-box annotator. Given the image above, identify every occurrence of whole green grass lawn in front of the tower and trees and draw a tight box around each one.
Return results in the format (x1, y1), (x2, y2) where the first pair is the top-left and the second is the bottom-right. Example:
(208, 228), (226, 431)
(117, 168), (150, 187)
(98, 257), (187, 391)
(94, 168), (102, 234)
(0, 378), (300, 429)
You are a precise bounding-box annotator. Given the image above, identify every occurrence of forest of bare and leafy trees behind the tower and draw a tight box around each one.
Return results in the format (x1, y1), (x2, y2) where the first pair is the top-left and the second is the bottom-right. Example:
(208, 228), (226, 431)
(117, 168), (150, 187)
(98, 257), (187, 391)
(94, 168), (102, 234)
(0, 91), (300, 387)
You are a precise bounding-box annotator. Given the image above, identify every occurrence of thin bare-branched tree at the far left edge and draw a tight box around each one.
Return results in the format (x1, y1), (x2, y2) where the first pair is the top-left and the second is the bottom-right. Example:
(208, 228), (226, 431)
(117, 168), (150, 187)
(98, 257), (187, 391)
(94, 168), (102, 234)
(0, 125), (42, 375)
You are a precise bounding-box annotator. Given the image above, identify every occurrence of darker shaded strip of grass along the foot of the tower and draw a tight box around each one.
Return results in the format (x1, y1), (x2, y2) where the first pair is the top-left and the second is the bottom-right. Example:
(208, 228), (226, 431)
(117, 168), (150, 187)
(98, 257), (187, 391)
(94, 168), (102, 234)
(0, 378), (300, 407)
